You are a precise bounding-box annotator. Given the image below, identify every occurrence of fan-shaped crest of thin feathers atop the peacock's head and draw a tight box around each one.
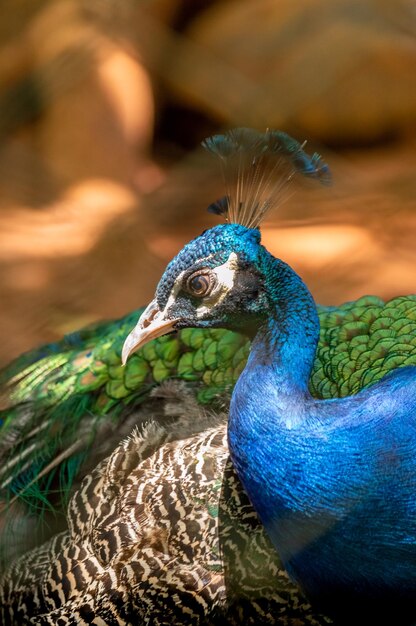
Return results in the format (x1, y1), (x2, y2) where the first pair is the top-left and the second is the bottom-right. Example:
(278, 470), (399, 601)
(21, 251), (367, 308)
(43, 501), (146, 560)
(202, 128), (331, 228)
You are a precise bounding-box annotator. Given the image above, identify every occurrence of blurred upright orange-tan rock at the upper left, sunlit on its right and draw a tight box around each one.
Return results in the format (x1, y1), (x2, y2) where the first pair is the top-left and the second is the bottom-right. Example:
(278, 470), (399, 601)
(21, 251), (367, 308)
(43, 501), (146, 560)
(31, 0), (154, 183)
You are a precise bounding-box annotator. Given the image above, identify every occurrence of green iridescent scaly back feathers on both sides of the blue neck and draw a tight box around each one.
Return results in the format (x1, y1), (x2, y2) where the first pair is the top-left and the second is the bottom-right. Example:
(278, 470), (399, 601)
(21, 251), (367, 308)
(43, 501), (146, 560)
(0, 296), (416, 510)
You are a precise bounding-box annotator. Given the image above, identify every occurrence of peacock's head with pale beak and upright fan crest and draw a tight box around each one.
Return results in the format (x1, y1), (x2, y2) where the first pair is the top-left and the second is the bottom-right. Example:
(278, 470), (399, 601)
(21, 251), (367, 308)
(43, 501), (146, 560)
(122, 128), (329, 363)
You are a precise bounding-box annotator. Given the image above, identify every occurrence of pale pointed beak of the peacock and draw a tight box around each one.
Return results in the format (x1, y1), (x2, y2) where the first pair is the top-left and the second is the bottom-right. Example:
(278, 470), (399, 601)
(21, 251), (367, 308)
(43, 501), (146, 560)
(121, 299), (179, 365)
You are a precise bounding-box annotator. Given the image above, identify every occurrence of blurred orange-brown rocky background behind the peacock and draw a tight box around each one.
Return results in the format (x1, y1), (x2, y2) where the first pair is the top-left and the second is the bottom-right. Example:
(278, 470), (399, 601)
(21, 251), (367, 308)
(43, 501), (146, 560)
(0, 0), (416, 363)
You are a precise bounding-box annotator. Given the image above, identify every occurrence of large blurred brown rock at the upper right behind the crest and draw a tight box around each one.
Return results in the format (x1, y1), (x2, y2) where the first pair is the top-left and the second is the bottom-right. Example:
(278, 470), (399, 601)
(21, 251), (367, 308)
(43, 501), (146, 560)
(181, 0), (416, 144)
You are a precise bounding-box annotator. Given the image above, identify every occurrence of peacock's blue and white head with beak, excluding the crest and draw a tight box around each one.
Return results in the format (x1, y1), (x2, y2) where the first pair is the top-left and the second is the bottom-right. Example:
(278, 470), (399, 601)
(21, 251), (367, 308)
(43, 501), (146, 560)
(123, 224), (267, 363)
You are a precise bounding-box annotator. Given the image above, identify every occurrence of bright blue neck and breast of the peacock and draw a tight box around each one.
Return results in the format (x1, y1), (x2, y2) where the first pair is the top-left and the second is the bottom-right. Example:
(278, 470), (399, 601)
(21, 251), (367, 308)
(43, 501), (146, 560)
(228, 247), (416, 623)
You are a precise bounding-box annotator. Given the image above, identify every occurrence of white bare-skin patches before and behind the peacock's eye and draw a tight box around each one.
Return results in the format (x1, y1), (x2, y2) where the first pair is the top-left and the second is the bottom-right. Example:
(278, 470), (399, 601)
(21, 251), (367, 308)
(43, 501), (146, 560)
(162, 252), (238, 317)
